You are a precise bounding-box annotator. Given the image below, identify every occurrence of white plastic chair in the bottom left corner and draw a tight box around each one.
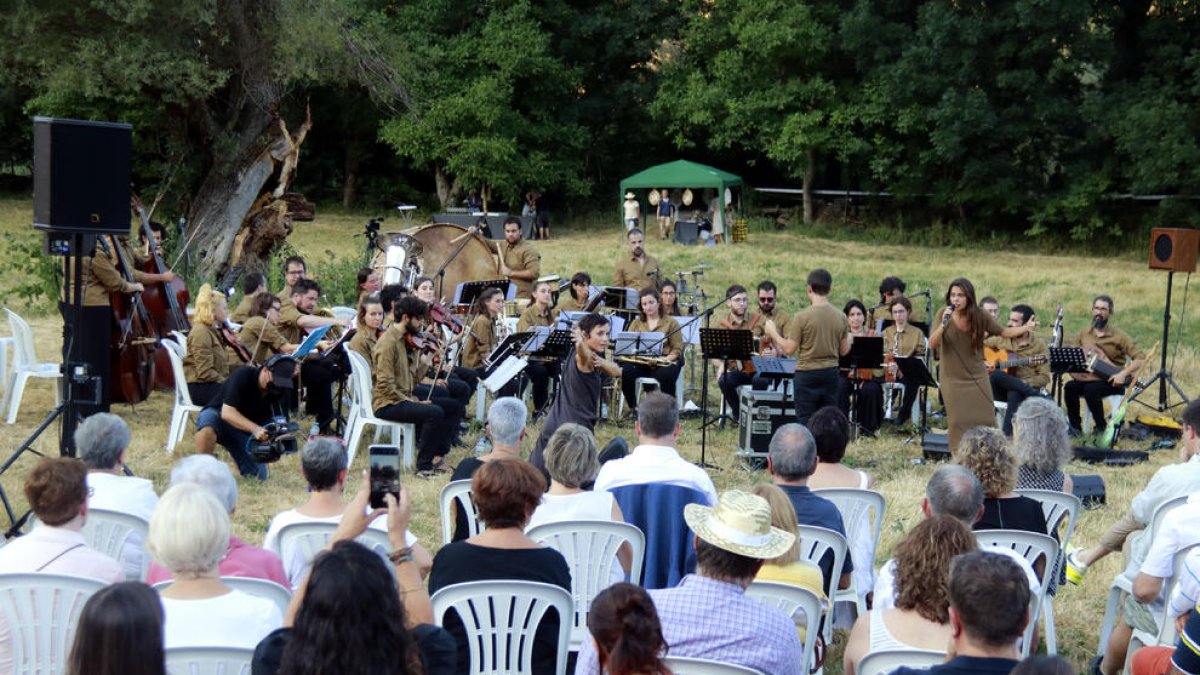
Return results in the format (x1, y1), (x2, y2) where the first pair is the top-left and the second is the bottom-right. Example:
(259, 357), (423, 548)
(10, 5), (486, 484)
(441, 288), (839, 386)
(0, 572), (108, 673)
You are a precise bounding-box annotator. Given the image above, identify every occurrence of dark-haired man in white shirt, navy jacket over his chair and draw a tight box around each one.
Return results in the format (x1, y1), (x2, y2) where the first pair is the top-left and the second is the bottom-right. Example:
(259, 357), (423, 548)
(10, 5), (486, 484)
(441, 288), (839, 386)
(593, 392), (716, 506)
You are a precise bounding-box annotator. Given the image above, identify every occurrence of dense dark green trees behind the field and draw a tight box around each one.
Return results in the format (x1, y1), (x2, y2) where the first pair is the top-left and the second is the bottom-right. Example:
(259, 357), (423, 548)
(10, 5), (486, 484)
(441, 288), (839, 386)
(0, 0), (1200, 254)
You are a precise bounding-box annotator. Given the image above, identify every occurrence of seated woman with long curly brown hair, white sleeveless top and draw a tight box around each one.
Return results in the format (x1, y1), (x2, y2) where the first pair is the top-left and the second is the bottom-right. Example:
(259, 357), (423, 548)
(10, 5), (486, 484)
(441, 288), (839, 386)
(842, 515), (978, 675)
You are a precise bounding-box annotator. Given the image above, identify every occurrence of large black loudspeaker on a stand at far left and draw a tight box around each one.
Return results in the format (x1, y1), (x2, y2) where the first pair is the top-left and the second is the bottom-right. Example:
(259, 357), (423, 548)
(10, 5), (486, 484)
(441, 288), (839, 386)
(34, 118), (133, 234)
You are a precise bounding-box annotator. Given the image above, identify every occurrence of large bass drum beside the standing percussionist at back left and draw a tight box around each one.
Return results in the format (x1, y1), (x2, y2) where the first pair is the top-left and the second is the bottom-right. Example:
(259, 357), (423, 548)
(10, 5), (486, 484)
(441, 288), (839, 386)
(404, 223), (503, 303)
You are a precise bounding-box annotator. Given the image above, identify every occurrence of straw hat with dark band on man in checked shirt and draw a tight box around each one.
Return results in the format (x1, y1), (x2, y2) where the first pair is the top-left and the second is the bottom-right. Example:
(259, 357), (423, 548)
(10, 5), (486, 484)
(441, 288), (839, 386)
(683, 490), (796, 560)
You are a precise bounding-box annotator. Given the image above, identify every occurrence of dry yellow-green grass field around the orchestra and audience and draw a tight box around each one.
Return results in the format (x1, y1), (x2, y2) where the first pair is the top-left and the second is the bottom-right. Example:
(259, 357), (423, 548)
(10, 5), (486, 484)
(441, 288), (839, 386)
(0, 193), (1200, 673)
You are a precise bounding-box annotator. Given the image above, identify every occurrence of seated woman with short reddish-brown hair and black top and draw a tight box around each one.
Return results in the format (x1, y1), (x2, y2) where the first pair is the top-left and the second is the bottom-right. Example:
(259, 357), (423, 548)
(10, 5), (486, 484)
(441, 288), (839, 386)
(430, 459), (571, 675)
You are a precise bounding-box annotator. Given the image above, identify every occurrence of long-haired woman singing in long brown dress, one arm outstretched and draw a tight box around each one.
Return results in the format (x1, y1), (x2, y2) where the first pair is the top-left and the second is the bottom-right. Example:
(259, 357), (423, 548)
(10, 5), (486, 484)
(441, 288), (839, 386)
(929, 279), (1037, 454)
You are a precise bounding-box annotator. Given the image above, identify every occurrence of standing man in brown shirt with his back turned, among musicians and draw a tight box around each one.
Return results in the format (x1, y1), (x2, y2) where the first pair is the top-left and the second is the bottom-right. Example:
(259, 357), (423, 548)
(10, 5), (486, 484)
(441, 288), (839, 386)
(763, 269), (852, 424)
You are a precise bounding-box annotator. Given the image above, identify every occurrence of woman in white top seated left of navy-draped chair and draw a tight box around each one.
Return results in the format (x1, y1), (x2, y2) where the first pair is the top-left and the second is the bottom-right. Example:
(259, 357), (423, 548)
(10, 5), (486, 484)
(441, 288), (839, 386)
(526, 422), (634, 584)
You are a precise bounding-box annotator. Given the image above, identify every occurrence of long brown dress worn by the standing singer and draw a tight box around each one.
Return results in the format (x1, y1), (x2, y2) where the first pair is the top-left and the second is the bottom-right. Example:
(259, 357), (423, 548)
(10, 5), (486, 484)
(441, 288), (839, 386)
(937, 313), (1004, 454)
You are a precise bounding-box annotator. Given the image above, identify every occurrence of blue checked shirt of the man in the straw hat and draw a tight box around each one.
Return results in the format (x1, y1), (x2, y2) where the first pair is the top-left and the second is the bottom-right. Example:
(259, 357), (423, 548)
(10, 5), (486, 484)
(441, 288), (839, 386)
(575, 574), (808, 675)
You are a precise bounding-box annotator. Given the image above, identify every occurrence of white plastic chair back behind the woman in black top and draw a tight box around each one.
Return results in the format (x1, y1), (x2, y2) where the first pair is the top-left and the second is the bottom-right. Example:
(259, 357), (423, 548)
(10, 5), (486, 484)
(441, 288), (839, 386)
(431, 580), (575, 675)
